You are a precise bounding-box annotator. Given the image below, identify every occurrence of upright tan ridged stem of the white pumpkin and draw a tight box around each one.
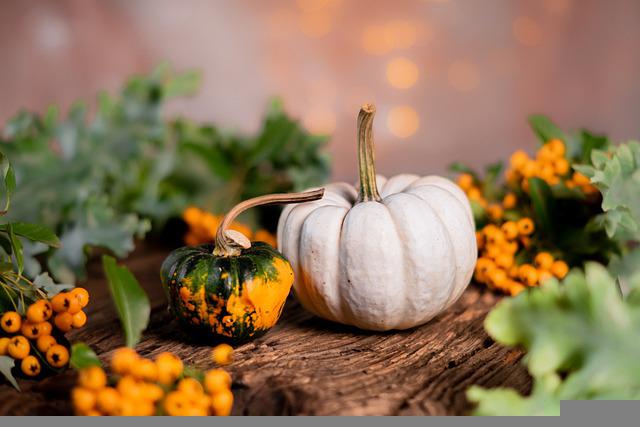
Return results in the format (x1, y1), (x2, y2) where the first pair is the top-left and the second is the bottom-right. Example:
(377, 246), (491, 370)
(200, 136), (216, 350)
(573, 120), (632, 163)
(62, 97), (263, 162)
(358, 104), (382, 203)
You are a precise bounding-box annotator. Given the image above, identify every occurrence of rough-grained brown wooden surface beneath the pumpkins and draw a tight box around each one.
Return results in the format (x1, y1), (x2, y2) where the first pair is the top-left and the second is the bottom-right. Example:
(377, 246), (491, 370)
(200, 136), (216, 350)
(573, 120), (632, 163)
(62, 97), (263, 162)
(0, 244), (531, 415)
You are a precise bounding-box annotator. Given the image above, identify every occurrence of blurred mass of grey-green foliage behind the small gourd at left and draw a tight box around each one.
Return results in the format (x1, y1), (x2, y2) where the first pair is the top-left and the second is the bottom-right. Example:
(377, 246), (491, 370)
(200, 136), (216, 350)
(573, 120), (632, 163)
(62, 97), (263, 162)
(0, 65), (329, 282)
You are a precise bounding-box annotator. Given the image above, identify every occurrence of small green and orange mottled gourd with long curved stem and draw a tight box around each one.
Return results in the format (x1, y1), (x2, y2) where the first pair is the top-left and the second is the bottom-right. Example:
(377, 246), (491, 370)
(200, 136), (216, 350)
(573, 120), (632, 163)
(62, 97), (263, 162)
(160, 189), (324, 342)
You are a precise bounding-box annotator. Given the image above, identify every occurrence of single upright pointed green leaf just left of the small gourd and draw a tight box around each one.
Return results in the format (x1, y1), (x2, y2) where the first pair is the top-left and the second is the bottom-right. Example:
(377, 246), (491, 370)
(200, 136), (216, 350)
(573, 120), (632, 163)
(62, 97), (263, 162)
(102, 255), (150, 347)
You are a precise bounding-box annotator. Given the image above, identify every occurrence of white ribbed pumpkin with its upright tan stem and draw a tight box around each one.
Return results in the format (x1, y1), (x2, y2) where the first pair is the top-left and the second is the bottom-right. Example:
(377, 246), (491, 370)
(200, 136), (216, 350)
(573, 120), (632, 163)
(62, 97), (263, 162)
(278, 105), (477, 331)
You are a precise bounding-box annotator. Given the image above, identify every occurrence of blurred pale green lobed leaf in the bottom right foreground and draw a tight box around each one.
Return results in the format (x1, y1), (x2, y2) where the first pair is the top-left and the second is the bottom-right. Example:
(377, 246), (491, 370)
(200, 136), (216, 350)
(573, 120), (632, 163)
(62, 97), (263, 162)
(468, 263), (640, 415)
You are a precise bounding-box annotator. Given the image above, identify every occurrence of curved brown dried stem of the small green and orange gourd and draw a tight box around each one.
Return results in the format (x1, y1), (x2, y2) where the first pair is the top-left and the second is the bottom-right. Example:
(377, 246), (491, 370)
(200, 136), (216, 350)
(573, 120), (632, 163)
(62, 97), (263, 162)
(213, 188), (324, 256)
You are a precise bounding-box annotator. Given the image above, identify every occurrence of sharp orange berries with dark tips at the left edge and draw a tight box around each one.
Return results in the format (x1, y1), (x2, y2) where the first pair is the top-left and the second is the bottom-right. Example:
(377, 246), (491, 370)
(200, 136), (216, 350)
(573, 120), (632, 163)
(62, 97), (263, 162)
(0, 288), (89, 377)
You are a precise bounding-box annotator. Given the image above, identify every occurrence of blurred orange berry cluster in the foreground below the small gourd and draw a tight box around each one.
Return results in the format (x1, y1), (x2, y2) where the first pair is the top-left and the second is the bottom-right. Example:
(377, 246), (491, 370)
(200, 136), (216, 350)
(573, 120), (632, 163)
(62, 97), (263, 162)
(71, 344), (233, 416)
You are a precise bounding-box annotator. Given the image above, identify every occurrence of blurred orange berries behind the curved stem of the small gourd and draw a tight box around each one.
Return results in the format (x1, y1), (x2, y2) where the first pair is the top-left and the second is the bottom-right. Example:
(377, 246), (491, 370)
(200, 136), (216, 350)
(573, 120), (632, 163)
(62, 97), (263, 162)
(182, 206), (277, 247)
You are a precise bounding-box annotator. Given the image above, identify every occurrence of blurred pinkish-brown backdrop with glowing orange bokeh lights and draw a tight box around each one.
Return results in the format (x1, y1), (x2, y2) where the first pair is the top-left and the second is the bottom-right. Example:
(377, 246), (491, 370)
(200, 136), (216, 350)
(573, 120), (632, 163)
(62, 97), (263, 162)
(0, 0), (640, 180)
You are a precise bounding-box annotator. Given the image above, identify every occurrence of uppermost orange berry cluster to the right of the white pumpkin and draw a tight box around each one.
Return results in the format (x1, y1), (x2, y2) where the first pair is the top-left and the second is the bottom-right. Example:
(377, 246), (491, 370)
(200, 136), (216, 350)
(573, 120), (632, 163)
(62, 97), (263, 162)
(505, 139), (598, 195)
